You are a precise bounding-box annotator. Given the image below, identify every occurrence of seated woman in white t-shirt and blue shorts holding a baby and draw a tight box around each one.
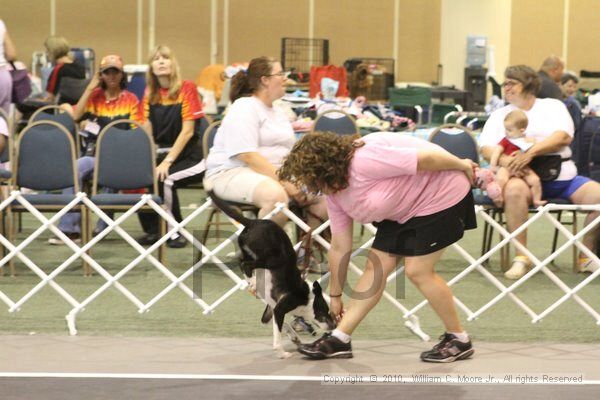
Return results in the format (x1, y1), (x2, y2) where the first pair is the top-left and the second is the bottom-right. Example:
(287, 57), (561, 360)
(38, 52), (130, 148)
(480, 65), (600, 279)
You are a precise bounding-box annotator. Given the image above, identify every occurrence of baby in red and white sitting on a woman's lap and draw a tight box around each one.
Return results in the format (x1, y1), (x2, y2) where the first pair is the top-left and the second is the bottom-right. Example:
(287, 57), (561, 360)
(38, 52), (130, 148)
(490, 110), (546, 207)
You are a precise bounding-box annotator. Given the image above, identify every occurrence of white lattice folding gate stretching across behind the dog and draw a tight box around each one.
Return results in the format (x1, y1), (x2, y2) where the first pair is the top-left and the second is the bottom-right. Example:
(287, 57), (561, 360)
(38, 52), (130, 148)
(0, 191), (600, 340)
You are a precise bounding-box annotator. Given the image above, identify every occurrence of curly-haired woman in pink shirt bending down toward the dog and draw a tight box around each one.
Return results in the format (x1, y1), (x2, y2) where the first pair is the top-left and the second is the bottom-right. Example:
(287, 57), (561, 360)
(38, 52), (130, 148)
(279, 132), (476, 362)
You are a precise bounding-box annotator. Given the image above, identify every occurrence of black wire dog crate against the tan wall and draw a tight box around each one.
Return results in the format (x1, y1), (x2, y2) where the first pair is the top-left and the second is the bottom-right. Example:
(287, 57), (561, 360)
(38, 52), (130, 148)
(281, 38), (329, 82)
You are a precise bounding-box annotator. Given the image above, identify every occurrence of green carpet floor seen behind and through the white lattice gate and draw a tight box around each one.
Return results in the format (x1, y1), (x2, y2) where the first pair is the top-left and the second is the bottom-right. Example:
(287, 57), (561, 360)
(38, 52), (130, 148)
(0, 190), (600, 342)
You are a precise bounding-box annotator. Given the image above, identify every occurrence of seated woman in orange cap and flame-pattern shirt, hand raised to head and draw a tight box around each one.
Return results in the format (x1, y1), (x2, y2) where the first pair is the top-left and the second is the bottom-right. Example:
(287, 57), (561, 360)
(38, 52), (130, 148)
(48, 55), (141, 245)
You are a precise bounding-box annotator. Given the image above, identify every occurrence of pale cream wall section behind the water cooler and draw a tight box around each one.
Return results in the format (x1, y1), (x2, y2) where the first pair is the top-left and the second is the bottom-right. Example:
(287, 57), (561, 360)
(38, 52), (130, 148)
(440, 0), (512, 88)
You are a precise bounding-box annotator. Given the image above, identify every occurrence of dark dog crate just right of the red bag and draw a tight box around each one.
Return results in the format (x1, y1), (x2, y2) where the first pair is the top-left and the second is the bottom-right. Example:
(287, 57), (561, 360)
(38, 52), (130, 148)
(344, 57), (395, 100)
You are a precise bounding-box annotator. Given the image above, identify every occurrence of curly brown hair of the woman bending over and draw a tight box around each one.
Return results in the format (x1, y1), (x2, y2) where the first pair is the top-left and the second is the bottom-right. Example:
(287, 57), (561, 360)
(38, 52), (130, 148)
(277, 132), (362, 193)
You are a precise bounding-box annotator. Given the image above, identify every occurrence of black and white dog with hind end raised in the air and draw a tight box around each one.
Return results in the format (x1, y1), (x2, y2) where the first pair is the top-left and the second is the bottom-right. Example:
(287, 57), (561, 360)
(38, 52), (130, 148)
(208, 191), (335, 358)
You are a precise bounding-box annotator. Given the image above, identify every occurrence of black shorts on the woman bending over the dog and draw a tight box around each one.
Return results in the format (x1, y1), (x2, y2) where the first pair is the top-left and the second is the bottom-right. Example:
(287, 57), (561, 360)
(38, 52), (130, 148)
(372, 190), (477, 256)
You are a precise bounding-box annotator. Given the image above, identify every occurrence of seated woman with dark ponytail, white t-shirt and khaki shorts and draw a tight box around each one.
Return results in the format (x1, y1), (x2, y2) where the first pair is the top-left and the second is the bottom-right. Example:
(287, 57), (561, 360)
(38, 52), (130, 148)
(204, 57), (327, 225)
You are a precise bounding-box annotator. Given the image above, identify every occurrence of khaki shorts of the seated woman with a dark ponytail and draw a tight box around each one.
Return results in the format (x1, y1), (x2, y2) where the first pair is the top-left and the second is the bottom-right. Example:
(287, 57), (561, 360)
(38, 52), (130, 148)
(204, 167), (271, 204)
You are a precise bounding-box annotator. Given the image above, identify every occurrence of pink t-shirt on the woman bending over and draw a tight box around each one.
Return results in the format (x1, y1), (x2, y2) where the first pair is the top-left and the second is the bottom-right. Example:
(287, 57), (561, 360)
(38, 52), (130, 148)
(327, 132), (471, 233)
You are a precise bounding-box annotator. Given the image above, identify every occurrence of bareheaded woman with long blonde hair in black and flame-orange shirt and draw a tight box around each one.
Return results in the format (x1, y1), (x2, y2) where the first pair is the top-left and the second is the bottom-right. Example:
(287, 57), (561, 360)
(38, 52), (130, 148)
(138, 46), (206, 248)
